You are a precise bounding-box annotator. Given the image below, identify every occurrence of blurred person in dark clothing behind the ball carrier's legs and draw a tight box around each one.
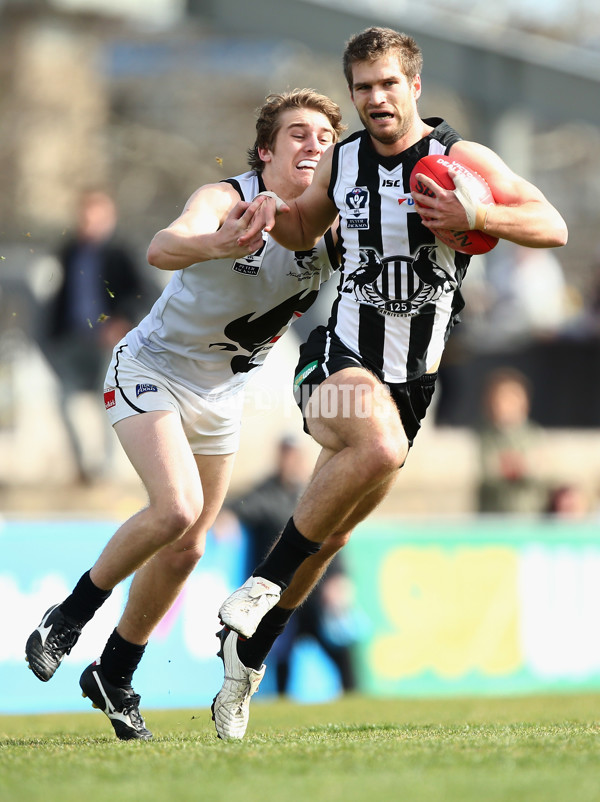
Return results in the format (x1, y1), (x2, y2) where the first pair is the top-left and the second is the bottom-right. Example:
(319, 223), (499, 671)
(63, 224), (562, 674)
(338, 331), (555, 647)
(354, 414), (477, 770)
(214, 437), (361, 695)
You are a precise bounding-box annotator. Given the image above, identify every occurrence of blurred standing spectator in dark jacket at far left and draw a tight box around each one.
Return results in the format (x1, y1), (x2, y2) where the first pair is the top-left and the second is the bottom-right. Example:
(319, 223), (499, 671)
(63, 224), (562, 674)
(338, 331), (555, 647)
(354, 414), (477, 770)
(41, 190), (144, 483)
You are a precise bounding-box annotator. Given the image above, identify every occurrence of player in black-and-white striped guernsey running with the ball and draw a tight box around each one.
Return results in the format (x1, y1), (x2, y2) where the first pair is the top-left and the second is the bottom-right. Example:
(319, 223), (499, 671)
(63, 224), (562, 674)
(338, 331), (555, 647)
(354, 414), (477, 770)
(219, 27), (567, 724)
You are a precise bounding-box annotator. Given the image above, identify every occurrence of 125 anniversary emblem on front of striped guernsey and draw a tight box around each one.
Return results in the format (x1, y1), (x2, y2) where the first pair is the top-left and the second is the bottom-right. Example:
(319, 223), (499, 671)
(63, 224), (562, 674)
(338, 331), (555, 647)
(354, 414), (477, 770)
(342, 245), (458, 317)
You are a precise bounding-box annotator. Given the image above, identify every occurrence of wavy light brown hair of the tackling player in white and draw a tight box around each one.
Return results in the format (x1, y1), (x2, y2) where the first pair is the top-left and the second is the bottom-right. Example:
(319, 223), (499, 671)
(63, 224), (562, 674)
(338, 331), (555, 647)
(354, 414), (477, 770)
(248, 89), (346, 173)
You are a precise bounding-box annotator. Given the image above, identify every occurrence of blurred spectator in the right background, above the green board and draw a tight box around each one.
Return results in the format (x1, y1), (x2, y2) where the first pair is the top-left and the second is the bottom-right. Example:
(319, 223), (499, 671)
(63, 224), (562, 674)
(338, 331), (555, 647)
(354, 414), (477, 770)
(478, 368), (546, 513)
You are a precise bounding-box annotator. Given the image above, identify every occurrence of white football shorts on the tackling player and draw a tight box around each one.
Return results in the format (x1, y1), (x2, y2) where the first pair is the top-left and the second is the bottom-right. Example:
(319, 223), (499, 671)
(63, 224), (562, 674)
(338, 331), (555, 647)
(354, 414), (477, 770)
(104, 340), (244, 455)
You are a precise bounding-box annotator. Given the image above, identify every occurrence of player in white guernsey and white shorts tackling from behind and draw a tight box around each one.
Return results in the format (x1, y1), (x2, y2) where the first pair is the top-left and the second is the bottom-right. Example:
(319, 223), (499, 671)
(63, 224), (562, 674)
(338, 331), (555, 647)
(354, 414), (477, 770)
(26, 89), (344, 740)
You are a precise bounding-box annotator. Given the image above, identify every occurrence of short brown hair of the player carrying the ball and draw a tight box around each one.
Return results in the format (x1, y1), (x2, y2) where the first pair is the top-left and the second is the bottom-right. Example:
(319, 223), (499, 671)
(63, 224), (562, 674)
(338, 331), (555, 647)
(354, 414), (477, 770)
(343, 27), (423, 89)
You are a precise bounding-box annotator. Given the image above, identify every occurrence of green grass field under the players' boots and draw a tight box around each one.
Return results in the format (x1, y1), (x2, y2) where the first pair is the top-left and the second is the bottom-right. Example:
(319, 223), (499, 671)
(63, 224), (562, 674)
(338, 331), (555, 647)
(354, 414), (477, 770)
(0, 695), (600, 802)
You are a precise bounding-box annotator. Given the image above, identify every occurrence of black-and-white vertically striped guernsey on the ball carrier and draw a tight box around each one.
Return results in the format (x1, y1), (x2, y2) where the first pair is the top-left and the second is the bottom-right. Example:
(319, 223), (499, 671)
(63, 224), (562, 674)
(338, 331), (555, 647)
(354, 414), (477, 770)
(328, 118), (470, 383)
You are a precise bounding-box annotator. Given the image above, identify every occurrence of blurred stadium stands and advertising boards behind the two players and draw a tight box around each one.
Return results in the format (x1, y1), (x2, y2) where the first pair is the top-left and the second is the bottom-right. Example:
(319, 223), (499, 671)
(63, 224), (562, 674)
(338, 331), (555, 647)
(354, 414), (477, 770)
(0, 0), (600, 712)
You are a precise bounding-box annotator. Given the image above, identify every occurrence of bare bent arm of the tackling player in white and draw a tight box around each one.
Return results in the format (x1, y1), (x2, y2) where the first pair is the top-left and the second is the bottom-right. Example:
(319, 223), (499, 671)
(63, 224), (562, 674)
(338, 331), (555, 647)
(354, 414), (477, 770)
(147, 183), (262, 270)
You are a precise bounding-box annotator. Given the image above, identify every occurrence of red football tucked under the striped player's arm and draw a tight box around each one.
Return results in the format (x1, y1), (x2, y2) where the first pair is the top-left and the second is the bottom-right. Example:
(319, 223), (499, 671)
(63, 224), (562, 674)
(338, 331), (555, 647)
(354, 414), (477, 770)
(410, 155), (498, 255)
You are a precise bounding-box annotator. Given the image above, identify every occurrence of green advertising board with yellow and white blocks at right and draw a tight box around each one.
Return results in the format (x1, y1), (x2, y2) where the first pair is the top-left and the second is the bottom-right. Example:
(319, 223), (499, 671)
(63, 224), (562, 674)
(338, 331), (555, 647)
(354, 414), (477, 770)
(347, 519), (600, 695)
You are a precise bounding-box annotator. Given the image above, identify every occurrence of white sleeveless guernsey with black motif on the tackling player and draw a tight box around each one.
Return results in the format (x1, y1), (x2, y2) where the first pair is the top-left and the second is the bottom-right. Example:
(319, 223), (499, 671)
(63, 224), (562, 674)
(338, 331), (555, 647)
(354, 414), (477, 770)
(126, 171), (337, 399)
